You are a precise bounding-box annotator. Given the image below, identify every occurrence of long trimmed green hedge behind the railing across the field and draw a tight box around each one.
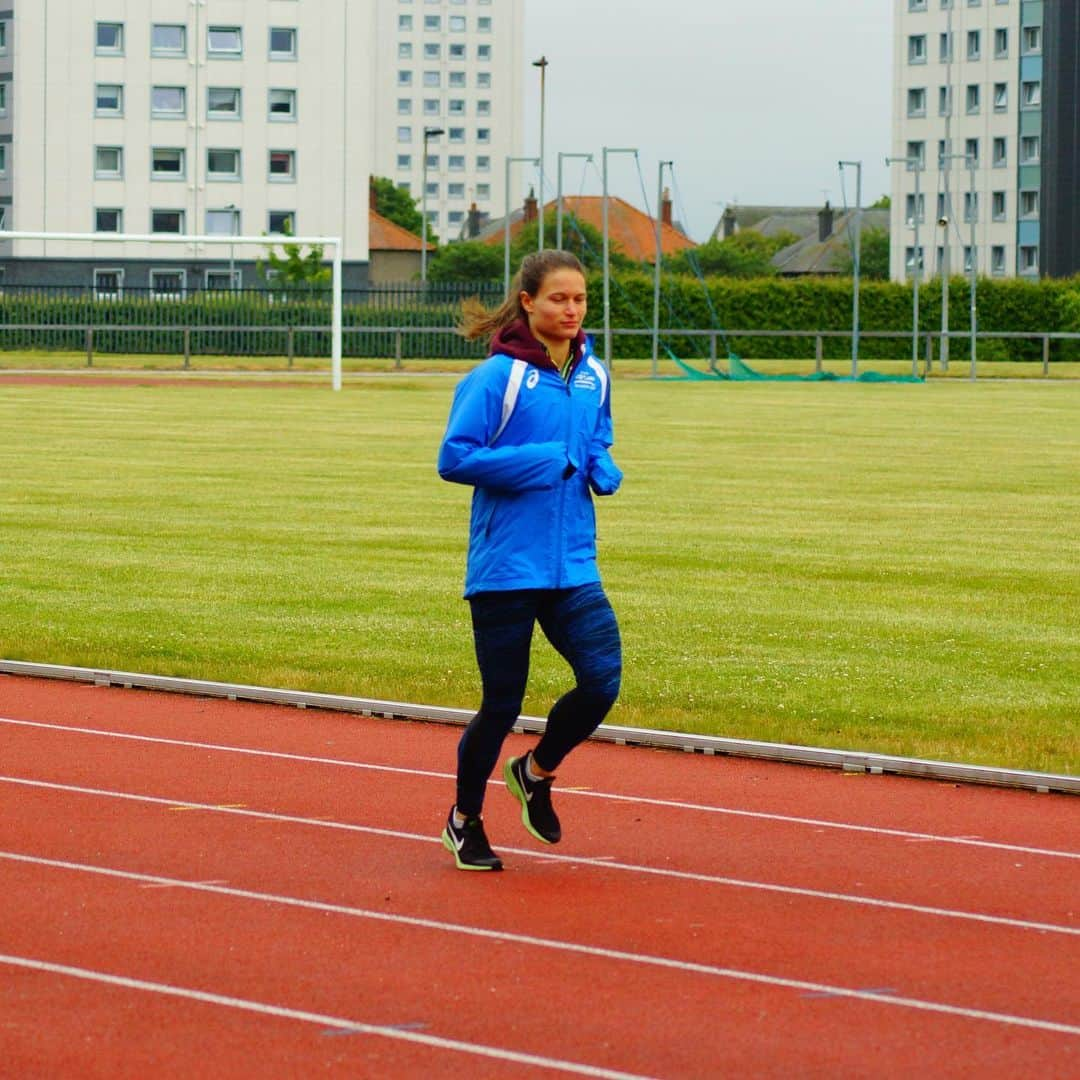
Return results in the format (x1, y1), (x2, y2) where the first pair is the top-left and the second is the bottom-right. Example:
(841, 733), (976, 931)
(0, 273), (1080, 361)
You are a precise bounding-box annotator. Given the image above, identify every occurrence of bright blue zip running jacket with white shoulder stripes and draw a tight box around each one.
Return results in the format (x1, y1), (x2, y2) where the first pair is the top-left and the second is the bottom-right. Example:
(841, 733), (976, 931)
(438, 345), (622, 596)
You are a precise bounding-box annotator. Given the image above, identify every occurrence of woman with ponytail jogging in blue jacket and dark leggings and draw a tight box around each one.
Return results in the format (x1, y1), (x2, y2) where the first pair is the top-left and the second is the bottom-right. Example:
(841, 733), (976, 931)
(438, 251), (622, 870)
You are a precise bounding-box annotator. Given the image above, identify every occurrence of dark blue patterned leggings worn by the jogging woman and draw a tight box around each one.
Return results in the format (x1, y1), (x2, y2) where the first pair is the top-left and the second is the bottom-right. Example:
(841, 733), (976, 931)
(457, 583), (622, 815)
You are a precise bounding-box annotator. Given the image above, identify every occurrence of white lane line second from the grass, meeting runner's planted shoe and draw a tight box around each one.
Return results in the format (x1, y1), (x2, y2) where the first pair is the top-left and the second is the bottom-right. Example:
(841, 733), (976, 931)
(0, 775), (1080, 936)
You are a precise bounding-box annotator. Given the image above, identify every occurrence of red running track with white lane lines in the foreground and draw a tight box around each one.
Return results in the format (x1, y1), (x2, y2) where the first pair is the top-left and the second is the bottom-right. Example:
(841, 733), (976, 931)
(0, 676), (1080, 1078)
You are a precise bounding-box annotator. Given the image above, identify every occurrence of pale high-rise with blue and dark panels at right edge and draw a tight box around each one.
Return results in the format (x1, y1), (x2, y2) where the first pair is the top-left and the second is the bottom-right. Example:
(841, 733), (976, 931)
(891, 0), (1080, 280)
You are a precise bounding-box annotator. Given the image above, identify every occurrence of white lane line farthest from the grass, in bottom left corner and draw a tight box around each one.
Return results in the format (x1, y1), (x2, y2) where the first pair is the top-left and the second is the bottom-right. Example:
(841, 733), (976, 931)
(0, 954), (646, 1080)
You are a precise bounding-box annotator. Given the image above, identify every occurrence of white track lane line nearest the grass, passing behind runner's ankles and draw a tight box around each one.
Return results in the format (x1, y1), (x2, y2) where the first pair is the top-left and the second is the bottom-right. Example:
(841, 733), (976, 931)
(0, 717), (1080, 860)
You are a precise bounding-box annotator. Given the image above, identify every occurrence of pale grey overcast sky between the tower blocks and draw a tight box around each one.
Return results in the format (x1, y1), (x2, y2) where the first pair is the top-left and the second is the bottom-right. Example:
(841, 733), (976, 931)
(525, 0), (893, 241)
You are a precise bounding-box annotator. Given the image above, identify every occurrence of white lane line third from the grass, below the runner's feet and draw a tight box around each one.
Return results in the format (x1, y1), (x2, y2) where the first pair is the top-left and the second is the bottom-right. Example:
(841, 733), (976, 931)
(0, 851), (1080, 1036)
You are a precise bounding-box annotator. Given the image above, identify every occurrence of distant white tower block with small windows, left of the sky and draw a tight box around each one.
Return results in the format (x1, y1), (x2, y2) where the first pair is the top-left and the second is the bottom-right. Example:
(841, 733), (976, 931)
(373, 0), (527, 240)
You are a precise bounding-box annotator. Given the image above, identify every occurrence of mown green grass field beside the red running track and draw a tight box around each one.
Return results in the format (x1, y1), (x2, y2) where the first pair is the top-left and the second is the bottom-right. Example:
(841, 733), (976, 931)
(0, 377), (1080, 774)
